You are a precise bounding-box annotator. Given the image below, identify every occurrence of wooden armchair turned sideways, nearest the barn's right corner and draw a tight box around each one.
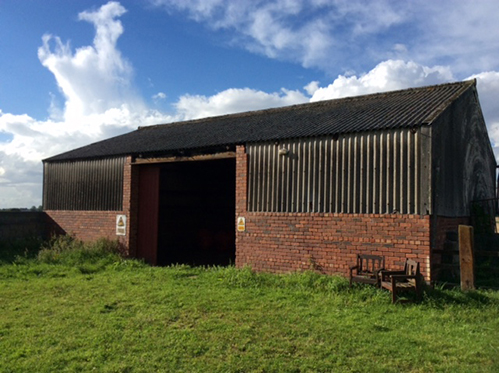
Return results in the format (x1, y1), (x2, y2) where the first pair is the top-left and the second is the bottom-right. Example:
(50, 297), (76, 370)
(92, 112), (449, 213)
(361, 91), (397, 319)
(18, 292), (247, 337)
(381, 259), (421, 303)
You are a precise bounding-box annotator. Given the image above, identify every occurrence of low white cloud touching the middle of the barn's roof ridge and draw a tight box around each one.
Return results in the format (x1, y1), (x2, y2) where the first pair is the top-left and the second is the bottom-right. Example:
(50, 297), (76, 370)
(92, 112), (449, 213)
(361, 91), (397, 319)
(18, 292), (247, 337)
(175, 88), (309, 119)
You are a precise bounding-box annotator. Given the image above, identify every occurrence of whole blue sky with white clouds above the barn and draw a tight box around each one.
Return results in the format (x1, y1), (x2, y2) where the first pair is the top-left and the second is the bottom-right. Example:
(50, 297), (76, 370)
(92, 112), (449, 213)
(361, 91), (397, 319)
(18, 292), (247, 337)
(0, 0), (499, 209)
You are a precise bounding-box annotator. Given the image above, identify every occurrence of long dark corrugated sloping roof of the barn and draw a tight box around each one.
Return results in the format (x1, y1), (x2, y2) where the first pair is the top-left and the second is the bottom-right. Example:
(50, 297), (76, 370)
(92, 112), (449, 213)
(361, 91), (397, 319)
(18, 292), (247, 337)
(45, 80), (476, 161)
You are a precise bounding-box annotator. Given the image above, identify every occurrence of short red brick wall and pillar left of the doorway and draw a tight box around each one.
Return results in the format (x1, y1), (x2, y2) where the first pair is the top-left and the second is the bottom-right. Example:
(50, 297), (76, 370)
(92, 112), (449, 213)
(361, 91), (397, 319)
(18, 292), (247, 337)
(45, 157), (132, 254)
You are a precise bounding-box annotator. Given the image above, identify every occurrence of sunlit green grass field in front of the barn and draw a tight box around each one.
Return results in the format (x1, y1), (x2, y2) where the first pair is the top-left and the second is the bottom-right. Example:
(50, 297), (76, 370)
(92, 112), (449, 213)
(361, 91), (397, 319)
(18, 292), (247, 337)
(0, 237), (499, 372)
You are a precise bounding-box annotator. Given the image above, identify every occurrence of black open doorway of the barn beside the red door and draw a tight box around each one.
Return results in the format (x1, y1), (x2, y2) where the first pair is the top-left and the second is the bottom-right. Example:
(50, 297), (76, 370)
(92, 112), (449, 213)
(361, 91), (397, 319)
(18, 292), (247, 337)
(157, 158), (236, 265)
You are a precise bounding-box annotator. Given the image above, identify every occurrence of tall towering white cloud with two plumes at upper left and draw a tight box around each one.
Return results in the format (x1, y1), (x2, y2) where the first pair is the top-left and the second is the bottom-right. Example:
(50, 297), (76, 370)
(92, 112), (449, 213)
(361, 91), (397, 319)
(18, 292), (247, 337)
(38, 2), (141, 122)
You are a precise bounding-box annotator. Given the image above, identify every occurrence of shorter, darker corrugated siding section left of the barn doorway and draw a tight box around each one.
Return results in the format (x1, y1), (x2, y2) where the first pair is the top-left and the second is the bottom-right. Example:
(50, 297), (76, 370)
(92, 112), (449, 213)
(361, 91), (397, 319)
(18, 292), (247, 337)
(43, 157), (125, 211)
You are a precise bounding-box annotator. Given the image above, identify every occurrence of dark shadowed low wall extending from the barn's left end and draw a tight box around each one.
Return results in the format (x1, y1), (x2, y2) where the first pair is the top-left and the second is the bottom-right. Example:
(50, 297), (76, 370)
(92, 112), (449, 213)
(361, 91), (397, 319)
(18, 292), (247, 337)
(0, 211), (48, 241)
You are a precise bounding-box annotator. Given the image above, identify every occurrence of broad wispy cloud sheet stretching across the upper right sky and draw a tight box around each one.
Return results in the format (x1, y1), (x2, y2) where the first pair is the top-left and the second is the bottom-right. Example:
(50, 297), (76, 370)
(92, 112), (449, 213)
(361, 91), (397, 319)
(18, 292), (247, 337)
(150, 0), (499, 77)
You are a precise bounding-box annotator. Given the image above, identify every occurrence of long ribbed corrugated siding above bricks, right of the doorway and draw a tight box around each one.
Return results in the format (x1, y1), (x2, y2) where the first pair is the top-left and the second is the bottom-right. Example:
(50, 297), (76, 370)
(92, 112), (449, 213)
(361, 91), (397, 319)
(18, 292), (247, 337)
(247, 129), (426, 214)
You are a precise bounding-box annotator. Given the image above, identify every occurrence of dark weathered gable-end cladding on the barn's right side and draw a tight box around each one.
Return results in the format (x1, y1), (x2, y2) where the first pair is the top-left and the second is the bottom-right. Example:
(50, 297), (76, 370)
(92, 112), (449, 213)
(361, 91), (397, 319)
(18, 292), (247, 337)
(431, 88), (496, 217)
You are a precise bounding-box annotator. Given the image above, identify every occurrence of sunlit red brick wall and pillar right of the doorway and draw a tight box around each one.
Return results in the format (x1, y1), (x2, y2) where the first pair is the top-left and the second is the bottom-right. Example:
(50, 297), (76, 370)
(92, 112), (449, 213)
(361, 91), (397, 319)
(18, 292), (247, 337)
(236, 146), (430, 279)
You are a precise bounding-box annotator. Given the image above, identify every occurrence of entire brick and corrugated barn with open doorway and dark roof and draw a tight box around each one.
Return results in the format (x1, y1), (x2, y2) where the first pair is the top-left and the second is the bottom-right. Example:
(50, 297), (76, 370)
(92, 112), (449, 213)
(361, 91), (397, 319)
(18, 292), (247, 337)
(43, 80), (496, 280)
